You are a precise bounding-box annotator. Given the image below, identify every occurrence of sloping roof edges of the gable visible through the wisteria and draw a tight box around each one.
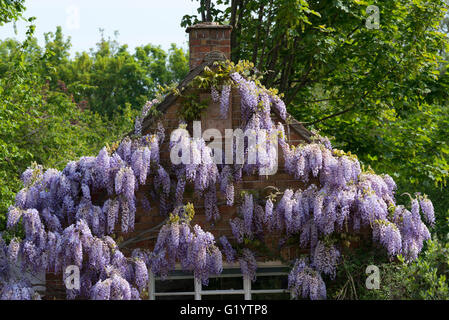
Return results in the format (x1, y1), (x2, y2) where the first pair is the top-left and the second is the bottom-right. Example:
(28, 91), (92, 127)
(142, 51), (313, 142)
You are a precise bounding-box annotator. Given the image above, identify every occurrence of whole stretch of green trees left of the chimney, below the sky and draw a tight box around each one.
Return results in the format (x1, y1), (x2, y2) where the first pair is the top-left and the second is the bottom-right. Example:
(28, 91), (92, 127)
(0, 26), (188, 230)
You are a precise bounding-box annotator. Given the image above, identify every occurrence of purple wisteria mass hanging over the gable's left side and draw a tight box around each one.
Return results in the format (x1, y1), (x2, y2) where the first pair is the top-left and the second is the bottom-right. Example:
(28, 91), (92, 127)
(0, 102), (169, 299)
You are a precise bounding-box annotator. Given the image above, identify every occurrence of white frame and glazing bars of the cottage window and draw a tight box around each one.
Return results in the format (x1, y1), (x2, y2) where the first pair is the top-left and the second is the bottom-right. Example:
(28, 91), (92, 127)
(148, 263), (291, 300)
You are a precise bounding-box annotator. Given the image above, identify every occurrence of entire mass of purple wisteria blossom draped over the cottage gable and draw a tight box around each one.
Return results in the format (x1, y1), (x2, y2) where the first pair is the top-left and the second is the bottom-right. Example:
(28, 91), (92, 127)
(0, 63), (435, 299)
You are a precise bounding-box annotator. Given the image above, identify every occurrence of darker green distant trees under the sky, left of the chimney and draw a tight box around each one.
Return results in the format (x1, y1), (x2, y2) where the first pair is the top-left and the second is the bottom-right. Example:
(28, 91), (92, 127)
(36, 27), (188, 118)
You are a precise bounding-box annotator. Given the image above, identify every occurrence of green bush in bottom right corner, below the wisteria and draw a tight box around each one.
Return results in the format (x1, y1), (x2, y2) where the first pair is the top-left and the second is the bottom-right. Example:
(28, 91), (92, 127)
(328, 239), (449, 300)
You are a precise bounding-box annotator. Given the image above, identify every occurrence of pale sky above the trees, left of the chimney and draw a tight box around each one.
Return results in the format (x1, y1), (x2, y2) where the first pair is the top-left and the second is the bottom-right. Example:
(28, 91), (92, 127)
(0, 0), (197, 55)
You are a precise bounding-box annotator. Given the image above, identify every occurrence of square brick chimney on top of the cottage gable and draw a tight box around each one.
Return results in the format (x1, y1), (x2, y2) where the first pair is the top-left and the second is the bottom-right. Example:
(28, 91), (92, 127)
(186, 22), (232, 70)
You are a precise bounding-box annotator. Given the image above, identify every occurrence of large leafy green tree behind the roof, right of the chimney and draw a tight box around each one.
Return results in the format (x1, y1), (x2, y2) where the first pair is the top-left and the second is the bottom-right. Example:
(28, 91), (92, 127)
(182, 0), (449, 234)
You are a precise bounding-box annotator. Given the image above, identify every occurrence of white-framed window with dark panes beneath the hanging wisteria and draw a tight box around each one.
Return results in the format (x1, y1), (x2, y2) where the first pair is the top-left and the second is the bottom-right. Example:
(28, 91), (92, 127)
(148, 265), (290, 300)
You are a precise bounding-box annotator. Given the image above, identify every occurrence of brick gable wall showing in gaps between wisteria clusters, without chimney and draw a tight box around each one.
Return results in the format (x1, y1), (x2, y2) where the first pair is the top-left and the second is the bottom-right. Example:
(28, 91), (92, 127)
(126, 89), (305, 260)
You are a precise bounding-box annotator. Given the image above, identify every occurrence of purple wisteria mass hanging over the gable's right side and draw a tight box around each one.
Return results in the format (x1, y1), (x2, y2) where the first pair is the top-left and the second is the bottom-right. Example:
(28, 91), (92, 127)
(230, 142), (435, 298)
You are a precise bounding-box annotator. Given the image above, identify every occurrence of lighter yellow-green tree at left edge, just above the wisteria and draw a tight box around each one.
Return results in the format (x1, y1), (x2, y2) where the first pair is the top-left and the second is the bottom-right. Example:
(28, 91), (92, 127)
(0, 35), (136, 230)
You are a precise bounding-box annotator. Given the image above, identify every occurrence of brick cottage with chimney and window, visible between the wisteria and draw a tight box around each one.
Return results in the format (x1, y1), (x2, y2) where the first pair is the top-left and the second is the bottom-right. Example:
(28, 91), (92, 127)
(47, 23), (312, 299)
